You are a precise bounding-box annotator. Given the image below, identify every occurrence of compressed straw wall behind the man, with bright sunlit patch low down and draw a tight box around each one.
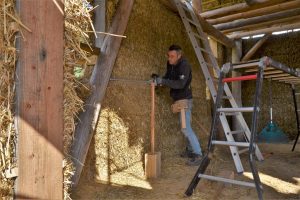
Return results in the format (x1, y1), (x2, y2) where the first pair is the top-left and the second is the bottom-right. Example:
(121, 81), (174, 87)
(79, 0), (211, 191)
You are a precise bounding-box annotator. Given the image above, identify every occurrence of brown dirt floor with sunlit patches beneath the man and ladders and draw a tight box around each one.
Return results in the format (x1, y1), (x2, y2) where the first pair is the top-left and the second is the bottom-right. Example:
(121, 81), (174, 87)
(72, 143), (300, 199)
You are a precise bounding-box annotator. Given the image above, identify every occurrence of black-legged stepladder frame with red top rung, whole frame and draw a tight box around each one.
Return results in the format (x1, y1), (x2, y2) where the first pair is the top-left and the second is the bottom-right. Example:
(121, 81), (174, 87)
(185, 64), (264, 199)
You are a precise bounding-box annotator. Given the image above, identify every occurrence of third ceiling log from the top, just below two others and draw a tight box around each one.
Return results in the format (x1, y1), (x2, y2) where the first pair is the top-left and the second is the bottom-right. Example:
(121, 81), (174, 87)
(214, 8), (300, 30)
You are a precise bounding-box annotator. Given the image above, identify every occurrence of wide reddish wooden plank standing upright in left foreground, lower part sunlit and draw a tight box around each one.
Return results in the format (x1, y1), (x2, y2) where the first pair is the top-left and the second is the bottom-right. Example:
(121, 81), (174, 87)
(16, 0), (64, 199)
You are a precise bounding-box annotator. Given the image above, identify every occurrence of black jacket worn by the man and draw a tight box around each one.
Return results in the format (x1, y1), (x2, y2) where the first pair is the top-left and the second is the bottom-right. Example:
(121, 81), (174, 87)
(162, 58), (192, 101)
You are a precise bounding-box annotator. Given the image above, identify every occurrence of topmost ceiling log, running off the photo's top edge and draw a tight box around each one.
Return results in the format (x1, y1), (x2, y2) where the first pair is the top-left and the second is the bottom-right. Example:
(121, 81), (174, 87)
(201, 0), (286, 19)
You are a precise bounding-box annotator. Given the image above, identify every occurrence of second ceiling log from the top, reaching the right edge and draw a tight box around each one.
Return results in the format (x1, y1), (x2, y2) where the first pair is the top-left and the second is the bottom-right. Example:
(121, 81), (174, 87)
(207, 0), (300, 25)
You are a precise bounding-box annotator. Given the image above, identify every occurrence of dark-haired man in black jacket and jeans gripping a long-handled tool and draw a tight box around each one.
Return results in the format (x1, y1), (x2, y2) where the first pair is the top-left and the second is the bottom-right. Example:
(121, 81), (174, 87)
(156, 45), (202, 165)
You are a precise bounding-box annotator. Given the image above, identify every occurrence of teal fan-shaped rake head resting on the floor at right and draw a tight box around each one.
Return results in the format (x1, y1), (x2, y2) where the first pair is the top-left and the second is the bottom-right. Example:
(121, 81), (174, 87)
(258, 121), (289, 143)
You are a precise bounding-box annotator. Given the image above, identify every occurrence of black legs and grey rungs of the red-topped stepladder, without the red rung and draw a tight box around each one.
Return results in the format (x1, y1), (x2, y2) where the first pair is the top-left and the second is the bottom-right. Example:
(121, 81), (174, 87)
(185, 64), (265, 199)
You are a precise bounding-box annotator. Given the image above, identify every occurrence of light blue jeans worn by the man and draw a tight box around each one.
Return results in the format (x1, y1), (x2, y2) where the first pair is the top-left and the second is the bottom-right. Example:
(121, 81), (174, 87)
(179, 99), (202, 155)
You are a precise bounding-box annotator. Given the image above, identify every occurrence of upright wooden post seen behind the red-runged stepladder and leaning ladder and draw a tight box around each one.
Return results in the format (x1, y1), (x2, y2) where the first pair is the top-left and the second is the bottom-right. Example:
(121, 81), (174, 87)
(232, 40), (244, 141)
